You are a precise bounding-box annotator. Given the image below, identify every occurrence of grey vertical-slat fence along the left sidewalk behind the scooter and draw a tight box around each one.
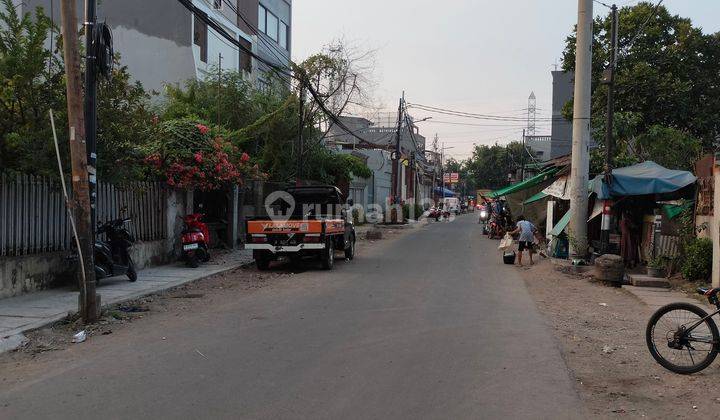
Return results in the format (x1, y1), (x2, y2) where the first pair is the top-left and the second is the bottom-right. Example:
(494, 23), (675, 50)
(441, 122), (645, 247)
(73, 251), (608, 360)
(0, 173), (167, 256)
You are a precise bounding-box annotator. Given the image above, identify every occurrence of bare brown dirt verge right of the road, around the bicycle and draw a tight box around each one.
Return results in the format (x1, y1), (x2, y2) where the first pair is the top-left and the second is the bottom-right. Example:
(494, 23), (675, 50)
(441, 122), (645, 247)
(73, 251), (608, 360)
(520, 260), (720, 419)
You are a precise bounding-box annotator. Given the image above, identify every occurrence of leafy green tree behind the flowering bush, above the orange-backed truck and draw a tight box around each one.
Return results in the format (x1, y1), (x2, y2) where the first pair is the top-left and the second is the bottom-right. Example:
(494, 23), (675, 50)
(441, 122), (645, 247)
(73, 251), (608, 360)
(163, 72), (371, 184)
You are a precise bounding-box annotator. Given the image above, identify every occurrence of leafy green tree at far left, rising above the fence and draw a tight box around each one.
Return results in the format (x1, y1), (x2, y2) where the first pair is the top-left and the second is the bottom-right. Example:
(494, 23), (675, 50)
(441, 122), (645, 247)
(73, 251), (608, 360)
(0, 0), (67, 175)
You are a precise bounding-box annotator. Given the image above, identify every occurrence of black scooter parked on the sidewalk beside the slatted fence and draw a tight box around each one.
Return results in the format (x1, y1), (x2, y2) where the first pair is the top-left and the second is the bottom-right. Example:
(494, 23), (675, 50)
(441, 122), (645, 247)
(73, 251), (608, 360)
(70, 219), (137, 283)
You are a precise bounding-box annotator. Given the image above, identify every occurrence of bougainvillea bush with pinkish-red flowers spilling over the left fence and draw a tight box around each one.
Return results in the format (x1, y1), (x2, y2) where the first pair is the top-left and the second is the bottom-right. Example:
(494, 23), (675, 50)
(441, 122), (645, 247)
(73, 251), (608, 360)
(144, 118), (258, 191)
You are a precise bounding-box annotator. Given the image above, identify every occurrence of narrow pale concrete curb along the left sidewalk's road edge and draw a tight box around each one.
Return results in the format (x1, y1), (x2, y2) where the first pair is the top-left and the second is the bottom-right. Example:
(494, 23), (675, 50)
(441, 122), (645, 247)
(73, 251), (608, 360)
(0, 260), (254, 355)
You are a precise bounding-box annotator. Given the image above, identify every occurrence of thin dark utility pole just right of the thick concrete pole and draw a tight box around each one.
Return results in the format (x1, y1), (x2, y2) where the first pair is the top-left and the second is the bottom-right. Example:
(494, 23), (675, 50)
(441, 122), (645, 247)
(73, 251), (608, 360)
(600, 4), (618, 253)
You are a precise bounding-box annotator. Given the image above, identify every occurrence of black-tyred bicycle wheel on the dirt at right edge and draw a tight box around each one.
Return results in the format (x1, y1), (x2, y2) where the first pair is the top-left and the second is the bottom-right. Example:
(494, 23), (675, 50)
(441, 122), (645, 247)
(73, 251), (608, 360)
(645, 303), (720, 375)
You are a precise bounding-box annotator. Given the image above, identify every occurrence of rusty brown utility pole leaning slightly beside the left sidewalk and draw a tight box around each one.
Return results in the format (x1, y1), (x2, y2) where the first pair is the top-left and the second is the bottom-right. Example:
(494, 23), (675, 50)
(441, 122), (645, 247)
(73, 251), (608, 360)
(60, 0), (100, 323)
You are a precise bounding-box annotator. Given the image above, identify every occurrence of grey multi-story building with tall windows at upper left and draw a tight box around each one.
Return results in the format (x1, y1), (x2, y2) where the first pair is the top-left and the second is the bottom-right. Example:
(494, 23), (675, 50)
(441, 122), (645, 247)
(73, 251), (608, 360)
(17, 0), (292, 91)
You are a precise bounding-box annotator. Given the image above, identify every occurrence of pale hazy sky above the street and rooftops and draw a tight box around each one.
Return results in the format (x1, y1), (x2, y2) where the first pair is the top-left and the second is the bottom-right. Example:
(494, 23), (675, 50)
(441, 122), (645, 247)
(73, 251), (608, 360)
(293, 0), (720, 159)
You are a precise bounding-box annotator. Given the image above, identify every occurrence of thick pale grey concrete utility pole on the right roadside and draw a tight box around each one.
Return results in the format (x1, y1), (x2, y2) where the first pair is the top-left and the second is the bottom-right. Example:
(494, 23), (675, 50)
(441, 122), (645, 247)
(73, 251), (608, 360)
(568, 0), (593, 258)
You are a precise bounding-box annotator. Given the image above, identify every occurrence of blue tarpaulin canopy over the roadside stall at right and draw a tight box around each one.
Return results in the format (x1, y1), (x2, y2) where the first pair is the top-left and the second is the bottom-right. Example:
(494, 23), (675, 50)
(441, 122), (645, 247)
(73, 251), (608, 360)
(591, 161), (697, 200)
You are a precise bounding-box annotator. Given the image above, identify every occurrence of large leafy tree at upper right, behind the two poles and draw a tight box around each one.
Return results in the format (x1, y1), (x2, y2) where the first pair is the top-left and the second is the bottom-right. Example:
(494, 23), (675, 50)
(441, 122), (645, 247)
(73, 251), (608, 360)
(563, 1), (720, 153)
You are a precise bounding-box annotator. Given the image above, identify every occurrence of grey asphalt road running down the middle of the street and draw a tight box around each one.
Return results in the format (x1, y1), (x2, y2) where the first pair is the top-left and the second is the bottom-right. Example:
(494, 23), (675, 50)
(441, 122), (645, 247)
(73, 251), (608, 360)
(0, 216), (584, 419)
